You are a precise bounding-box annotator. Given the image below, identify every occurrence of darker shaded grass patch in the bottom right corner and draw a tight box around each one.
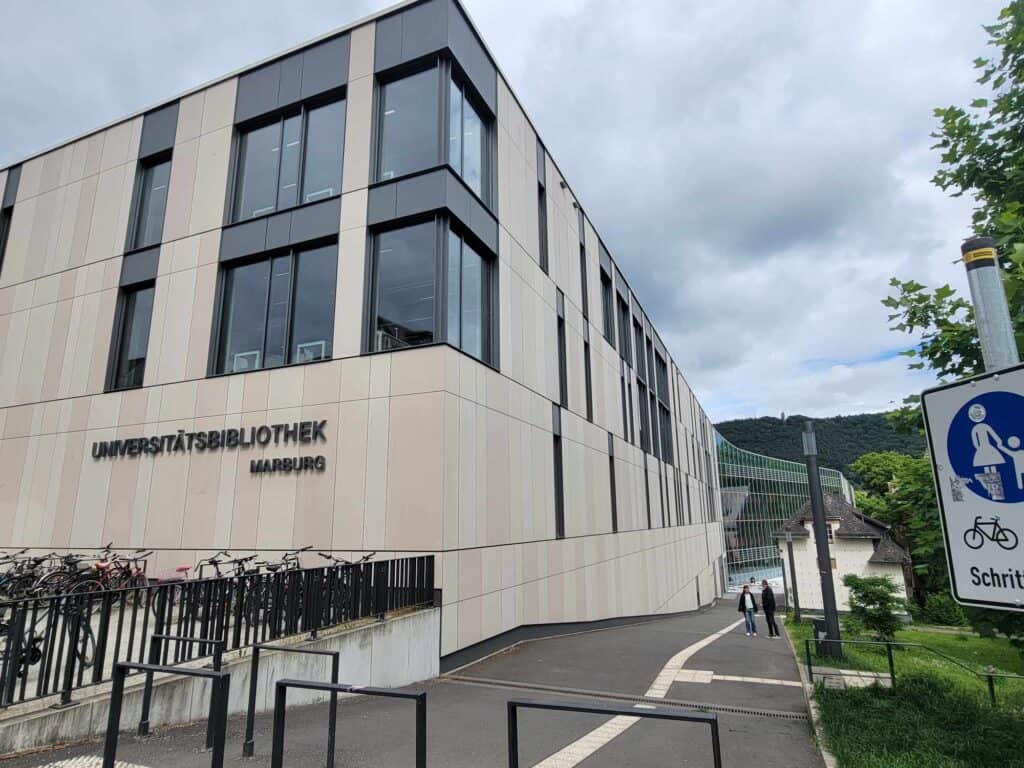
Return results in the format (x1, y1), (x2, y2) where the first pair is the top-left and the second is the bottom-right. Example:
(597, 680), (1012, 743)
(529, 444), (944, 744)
(814, 674), (1024, 768)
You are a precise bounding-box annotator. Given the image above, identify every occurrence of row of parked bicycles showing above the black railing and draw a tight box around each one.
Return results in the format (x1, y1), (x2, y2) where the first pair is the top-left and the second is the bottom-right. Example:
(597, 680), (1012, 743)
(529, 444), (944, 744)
(0, 542), (376, 602)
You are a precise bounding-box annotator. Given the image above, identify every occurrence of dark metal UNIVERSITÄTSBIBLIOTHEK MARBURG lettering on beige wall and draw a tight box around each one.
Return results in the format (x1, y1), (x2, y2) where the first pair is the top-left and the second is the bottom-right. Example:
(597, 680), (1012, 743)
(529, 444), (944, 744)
(92, 421), (327, 474)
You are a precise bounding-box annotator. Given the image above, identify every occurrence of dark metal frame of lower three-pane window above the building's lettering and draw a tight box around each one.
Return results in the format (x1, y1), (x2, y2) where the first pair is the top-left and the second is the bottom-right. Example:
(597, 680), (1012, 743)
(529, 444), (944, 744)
(207, 237), (340, 377)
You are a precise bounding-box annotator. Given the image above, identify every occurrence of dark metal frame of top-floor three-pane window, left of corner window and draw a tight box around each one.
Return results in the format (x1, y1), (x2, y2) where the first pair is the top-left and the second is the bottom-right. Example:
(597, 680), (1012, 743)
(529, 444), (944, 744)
(224, 86), (348, 226)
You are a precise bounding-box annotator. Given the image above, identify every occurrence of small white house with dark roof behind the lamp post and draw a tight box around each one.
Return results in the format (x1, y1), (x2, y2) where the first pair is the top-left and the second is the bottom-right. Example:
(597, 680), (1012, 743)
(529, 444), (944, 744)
(775, 494), (910, 611)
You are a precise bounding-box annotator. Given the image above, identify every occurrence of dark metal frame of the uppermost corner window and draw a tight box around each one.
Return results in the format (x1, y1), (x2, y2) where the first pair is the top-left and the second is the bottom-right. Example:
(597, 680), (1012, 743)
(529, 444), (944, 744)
(370, 56), (498, 213)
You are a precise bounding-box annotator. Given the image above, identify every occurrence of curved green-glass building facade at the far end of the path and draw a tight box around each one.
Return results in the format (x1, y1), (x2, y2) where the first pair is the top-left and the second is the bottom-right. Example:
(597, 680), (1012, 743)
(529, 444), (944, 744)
(715, 432), (853, 592)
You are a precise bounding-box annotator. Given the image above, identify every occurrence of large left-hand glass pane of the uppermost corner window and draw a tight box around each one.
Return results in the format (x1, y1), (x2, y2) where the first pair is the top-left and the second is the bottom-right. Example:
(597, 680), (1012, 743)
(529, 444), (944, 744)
(377, 69), (438, 180)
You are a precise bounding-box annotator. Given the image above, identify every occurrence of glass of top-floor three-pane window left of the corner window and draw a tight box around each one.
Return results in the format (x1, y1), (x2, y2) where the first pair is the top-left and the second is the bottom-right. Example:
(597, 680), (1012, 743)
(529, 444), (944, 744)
(232, 99), (345, 221)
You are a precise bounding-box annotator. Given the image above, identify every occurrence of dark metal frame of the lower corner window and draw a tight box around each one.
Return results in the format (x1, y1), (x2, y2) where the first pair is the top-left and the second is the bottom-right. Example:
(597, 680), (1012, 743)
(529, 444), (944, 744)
(362, 212), (501, 371)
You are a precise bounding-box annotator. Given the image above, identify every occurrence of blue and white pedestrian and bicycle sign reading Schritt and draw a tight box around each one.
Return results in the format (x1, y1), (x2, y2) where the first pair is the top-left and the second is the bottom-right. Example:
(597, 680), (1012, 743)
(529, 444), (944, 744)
(922, 366), (1024, 610)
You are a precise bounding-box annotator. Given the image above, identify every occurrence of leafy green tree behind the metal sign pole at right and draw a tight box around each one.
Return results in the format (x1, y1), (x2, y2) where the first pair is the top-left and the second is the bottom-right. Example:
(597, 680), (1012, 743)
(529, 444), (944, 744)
(883, 0), (1024, 652)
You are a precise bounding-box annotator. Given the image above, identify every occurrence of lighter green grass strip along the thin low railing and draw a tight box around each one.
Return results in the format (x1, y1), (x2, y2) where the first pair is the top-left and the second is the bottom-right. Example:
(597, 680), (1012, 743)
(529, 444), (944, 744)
(786, 622), (1024, 712)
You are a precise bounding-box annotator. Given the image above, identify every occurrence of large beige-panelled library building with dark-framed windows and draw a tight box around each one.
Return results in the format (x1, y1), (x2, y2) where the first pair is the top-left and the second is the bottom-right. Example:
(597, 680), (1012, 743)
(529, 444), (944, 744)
(0, 0), (725, 653)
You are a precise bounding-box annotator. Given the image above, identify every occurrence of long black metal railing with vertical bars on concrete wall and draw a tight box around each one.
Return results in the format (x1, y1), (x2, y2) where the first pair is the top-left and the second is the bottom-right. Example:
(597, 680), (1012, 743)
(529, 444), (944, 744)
(0, 555), (434, 707)
